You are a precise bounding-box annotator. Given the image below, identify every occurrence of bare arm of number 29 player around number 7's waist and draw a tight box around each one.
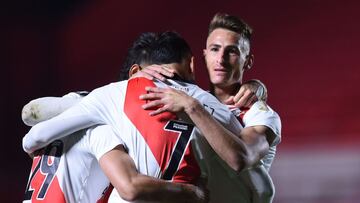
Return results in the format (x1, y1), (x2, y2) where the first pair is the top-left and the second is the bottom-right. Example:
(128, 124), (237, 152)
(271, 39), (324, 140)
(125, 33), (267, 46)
(99, 145), (207, 203)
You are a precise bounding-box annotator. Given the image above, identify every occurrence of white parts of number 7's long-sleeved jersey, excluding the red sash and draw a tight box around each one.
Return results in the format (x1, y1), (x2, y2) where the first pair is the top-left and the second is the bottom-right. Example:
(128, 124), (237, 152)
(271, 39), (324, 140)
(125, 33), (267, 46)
(23, 80), (242, 203)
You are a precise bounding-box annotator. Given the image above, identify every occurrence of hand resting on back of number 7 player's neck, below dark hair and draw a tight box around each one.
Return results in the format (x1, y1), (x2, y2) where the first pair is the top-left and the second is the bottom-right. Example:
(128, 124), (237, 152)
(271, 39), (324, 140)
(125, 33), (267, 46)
(131, 64), (174, 81)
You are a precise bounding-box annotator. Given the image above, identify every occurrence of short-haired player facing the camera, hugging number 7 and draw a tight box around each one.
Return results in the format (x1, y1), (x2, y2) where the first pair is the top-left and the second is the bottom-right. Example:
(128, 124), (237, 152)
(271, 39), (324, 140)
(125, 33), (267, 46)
(138, 13), (281, 202)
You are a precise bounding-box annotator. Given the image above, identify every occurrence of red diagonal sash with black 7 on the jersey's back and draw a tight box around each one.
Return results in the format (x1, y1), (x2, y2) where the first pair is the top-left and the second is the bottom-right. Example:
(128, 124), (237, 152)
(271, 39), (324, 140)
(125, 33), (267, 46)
(124, 78), (200, 183)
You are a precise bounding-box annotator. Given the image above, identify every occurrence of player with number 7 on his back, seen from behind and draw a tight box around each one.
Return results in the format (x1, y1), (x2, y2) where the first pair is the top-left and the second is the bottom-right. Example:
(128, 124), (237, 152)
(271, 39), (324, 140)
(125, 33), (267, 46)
(23, 32), (241, 201)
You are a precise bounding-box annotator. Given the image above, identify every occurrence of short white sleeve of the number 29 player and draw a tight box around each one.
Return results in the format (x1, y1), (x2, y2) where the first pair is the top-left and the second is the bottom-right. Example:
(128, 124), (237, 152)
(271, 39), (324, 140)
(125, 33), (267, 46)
(87, 125), (124, 160)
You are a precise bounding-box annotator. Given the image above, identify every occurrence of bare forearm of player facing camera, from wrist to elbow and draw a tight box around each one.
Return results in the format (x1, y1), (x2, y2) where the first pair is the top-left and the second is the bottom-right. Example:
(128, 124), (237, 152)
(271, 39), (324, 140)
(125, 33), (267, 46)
(184, 99), (252, 171)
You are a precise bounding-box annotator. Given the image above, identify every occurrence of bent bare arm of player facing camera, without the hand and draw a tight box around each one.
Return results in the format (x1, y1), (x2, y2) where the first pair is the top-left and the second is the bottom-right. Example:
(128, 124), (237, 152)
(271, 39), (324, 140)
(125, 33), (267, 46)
(184, 99), (269, 171)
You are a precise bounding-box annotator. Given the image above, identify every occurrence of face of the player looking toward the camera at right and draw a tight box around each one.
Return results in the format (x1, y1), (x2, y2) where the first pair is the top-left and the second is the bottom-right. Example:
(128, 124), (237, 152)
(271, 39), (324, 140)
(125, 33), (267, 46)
(204, 28), (249, 87)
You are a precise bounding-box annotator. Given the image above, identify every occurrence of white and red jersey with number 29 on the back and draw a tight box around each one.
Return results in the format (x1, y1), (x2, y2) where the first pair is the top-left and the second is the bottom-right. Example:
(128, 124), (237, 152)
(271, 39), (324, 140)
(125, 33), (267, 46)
(23, 125), (122, 203)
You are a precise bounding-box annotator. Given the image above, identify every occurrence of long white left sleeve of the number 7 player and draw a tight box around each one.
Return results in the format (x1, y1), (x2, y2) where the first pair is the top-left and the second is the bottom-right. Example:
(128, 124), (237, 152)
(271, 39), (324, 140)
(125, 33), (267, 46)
(23, 88), (104, 153)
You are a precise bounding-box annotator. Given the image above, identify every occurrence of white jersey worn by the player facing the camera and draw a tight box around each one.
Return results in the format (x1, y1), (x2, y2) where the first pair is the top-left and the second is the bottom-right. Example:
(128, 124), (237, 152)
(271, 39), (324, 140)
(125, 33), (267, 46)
(199, 101), (281, 203)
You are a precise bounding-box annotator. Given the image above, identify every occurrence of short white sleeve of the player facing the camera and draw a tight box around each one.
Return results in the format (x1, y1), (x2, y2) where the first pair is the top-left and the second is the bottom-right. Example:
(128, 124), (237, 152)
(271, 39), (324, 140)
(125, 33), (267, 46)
(243, 101), (281, 146)
